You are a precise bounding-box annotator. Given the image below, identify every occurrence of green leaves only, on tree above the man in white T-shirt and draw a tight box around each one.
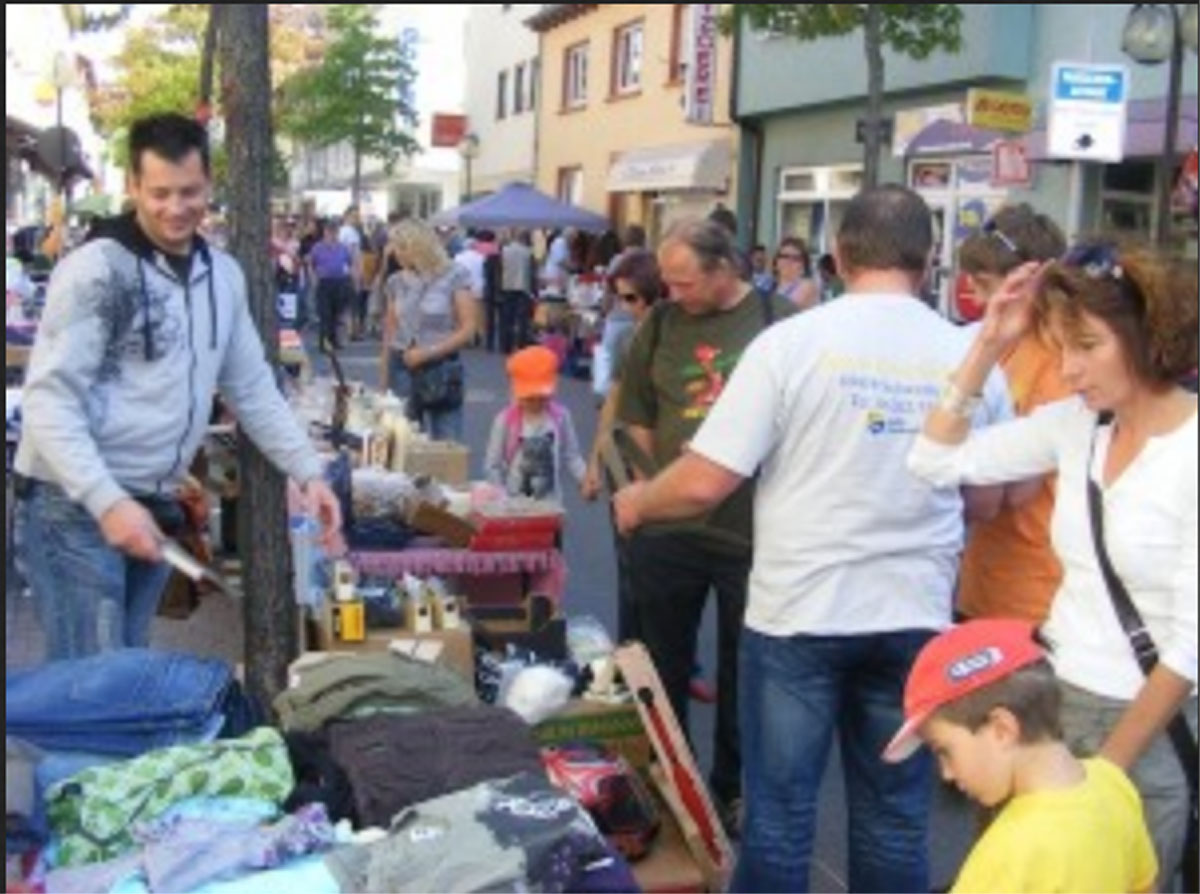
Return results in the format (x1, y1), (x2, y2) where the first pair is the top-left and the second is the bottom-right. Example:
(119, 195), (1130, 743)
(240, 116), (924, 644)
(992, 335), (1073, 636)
(722, 4), (962, 60)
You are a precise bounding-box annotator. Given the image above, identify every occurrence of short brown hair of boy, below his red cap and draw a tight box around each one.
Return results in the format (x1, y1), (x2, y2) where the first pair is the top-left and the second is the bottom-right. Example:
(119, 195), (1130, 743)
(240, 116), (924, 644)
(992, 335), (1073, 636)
(934, 659), (1062, 745)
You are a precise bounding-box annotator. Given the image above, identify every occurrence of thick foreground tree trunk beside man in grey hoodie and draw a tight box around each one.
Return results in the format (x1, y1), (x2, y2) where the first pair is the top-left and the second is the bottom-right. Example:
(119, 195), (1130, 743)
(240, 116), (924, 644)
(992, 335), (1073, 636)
(220, 4), (296, 706)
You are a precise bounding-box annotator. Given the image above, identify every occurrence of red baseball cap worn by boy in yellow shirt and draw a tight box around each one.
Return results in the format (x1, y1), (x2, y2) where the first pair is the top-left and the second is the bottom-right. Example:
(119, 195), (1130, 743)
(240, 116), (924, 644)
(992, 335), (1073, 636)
(883, 618), (1045, 763)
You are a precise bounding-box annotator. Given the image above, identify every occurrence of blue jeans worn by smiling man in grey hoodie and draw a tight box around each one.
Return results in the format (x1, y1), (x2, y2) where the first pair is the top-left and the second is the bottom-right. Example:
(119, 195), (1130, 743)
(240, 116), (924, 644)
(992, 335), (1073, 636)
(17, 481), (170, 660)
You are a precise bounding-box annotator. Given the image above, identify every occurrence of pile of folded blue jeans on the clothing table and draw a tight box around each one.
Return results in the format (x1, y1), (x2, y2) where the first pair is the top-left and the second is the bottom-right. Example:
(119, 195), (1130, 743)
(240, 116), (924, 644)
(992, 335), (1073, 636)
(5, 649), (256, 757)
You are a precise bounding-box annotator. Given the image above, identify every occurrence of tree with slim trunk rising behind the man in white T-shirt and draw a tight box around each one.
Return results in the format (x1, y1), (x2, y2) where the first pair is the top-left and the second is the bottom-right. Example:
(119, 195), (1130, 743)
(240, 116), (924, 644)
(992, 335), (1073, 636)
(722, 4), (962, 186)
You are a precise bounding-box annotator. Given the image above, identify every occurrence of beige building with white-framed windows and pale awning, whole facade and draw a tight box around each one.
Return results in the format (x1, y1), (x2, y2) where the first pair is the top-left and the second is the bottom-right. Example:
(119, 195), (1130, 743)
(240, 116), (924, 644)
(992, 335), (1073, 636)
(529, 4), (738, 240)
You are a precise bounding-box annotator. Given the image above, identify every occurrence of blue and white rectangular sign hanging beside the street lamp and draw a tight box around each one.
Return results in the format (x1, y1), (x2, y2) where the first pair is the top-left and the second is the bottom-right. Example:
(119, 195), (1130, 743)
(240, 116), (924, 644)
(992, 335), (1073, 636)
(1046, 62), (1129, 162)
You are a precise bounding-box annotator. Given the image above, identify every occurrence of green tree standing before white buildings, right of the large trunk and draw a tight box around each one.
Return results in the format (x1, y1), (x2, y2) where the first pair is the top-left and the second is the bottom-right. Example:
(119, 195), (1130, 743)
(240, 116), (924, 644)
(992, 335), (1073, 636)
(280, 4), (418, 198)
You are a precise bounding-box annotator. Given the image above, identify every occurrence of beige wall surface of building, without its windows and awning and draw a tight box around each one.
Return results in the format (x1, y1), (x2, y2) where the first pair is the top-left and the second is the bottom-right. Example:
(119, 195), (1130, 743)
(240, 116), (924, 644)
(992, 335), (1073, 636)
(538, 4), (737, 236)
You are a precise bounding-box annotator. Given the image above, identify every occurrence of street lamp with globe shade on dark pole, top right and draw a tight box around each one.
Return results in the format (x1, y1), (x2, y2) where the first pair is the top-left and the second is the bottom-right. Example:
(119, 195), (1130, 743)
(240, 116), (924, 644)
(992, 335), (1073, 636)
(1121, 4), (1196, 245)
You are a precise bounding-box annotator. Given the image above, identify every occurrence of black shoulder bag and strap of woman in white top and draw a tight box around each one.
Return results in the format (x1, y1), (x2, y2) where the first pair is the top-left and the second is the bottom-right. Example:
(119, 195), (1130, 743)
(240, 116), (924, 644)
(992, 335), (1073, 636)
(1087, 414), (1200, 894)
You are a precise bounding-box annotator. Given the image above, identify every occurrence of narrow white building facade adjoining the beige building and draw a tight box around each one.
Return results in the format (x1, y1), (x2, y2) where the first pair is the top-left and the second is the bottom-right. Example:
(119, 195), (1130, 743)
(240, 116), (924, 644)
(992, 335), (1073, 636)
(463, 4), (541, 197)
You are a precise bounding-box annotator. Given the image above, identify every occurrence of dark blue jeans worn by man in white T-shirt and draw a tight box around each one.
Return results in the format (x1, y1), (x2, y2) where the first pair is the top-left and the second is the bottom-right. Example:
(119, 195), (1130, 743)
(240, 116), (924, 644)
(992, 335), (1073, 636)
(731, 629), (932, 892)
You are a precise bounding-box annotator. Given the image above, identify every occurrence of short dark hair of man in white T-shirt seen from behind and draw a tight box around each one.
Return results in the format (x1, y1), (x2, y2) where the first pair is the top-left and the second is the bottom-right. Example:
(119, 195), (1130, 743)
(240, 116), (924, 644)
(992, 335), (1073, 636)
(838, 184), (934, 274)
